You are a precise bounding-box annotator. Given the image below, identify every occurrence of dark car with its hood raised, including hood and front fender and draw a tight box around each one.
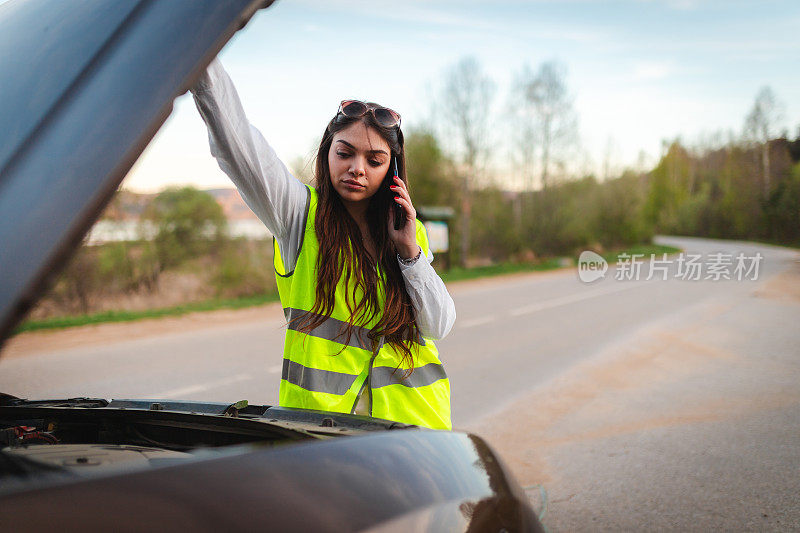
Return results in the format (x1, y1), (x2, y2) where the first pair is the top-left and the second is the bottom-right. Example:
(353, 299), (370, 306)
(0, 0), (541, 531)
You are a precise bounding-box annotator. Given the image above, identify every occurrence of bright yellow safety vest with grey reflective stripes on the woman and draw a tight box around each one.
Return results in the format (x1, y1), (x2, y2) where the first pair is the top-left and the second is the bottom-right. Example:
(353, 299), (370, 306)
(274, 186), (452, 429)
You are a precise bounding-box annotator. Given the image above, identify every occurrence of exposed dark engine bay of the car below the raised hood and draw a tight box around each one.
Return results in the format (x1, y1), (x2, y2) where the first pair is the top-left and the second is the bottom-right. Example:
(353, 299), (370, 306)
(0, 397), (338, 492)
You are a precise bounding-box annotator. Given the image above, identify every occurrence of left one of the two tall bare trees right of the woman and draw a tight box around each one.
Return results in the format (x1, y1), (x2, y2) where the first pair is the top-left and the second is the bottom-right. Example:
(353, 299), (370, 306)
(441, 57), (495, 266)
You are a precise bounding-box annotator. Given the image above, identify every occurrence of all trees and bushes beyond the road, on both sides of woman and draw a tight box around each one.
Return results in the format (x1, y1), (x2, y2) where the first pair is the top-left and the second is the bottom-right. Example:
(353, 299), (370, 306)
(34, 58), (800, 318)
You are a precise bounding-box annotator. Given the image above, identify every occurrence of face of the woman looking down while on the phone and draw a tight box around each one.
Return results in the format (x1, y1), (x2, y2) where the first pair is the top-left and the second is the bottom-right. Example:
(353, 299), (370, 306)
(328, 121), (392, 210)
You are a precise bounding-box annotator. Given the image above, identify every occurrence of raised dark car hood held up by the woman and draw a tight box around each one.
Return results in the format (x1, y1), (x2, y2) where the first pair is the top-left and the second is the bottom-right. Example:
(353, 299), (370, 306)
(0, 0), (273, 343)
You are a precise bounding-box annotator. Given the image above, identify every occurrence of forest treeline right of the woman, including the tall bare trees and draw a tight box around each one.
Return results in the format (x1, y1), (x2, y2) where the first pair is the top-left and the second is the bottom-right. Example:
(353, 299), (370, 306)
(406, 58), (800, 265)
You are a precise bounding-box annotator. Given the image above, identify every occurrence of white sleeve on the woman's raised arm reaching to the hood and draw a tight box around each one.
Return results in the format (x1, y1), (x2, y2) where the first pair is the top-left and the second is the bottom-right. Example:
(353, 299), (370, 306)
(191, 59), (308, 270)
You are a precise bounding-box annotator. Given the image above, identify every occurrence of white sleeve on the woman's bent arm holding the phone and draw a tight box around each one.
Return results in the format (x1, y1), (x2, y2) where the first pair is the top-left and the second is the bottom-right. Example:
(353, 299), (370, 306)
(400, 246), (456, 340)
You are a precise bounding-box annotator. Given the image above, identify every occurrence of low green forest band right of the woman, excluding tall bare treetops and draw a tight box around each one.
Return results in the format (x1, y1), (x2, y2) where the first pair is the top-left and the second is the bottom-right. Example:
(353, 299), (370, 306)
(406, 124), (800, 261)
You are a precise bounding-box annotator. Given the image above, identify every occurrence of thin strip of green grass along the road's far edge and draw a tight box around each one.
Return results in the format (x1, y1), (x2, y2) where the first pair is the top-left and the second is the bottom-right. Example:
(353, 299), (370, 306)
(14, 244), (680, 334)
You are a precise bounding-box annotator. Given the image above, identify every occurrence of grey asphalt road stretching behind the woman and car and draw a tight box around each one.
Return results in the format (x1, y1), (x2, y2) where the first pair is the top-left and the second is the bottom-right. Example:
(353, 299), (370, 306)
(0, 237), (800, 531)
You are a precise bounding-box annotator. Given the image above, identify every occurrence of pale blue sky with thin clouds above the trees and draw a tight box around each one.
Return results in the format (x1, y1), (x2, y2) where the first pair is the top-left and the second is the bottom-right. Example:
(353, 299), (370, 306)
(123, 0), (800, 192)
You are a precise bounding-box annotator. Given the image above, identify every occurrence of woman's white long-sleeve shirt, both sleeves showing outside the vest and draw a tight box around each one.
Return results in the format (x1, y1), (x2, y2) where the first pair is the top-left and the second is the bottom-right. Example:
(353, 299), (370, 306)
(192, 59), (456, 339)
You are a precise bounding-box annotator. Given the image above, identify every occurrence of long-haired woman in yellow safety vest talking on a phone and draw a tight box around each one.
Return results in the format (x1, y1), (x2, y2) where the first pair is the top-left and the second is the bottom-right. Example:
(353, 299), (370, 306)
(192, 60), (455, 429)
